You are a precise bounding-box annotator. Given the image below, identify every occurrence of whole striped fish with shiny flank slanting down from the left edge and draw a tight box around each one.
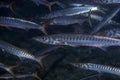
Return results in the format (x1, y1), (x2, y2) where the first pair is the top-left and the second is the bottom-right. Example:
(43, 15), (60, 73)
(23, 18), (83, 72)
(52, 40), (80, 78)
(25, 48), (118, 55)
(0, 40), (46, 68)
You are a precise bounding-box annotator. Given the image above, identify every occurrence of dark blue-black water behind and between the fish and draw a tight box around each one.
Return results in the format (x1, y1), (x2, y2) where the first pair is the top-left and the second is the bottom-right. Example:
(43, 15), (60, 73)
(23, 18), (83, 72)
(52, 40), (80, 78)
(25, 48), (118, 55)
(0, 0), (120, 80)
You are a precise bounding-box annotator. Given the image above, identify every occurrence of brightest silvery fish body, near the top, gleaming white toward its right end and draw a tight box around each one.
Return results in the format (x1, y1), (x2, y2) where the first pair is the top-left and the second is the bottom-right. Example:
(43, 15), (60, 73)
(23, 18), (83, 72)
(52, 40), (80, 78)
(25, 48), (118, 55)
(41, 6), (99, 19)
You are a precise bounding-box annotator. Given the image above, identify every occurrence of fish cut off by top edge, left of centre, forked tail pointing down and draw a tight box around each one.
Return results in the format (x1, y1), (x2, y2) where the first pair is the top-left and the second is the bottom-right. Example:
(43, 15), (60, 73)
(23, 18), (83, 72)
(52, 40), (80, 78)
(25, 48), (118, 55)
(31, 0), (57, 11)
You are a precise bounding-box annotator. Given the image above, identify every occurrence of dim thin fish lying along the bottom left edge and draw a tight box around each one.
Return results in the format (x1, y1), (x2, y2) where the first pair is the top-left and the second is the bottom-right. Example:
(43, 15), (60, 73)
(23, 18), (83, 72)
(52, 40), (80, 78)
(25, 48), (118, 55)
(0, 73), (42, 80)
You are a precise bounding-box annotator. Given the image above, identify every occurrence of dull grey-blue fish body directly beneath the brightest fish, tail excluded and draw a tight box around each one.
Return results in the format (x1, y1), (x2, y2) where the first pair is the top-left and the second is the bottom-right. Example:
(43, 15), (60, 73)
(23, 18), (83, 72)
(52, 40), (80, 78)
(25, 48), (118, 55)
(50, 16), (87, 25)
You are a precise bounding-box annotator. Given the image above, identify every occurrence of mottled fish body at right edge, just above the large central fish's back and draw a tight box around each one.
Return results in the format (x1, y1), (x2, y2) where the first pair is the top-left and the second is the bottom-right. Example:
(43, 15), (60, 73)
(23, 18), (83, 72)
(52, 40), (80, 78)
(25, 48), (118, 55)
(96, 28), (120, 38)
